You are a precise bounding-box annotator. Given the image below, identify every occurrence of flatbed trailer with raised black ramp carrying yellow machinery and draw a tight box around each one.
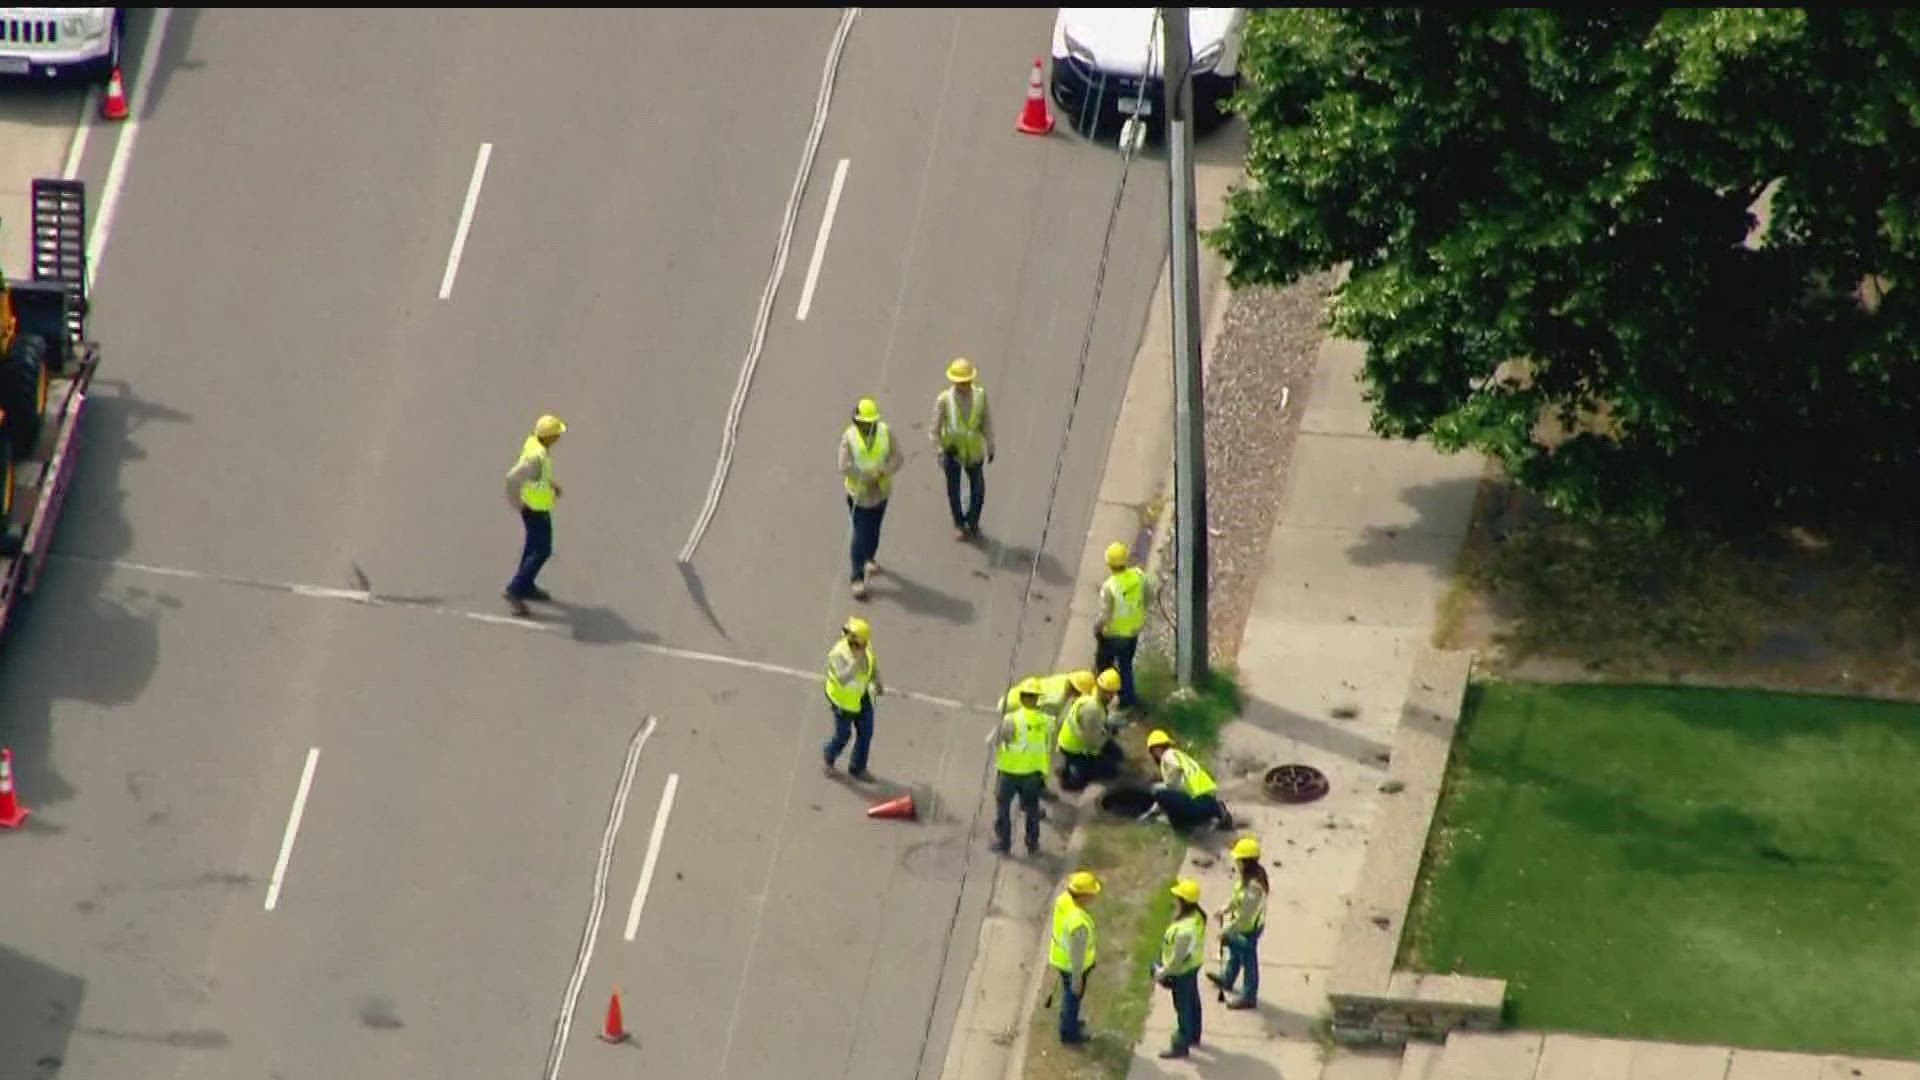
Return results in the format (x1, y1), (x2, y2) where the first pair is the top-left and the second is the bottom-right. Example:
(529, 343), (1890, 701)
(0, 179), (100, 632)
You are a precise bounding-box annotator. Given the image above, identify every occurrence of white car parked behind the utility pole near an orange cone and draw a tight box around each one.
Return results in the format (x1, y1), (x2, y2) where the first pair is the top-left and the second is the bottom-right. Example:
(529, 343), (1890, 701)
(1052, 8), (1246, 133)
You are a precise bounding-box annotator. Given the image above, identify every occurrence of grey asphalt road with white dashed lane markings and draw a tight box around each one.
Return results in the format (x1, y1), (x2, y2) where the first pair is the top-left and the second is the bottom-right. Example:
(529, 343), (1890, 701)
(0, 10), (1165, 1080)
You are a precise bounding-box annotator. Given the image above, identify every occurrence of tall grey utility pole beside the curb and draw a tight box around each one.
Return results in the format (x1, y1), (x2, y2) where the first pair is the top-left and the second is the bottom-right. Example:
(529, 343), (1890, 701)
(1160, 8), (1208, 688)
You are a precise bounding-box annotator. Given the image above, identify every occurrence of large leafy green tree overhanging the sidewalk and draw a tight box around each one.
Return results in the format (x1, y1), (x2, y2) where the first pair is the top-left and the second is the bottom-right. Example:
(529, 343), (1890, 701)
(1212, 8), (1920, 523)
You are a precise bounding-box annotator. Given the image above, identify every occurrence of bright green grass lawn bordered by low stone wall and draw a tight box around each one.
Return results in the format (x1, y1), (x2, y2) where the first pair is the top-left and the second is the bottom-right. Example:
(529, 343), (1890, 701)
(1402, 682), (1920, 1057)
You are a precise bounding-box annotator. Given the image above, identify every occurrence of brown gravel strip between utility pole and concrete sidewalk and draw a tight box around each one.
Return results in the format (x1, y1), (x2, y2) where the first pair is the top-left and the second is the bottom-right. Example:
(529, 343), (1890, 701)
(1146, 273), (1334, 663)
